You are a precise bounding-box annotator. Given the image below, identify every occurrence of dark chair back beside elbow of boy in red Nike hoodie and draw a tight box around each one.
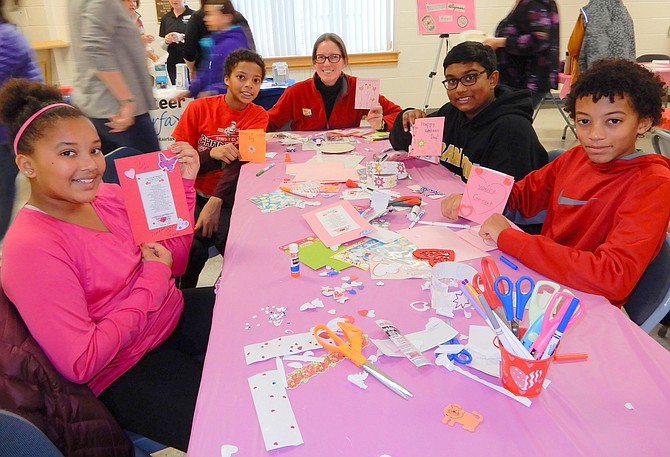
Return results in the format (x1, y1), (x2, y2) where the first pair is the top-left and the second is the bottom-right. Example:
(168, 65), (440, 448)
(624, 234), (670, 333)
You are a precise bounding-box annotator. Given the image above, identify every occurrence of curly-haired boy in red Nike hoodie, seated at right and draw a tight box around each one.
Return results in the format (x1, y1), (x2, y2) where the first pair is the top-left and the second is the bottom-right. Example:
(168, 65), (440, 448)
(442, 58), (670, 307)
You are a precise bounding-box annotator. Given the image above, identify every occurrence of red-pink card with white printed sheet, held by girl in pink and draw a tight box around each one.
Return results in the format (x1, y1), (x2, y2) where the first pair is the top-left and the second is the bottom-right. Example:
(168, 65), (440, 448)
(114, 150), (193, 245)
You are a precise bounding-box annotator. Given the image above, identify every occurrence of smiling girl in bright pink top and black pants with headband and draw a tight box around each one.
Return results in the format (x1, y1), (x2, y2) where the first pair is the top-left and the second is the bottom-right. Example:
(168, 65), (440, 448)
(0, 79), (214, 450)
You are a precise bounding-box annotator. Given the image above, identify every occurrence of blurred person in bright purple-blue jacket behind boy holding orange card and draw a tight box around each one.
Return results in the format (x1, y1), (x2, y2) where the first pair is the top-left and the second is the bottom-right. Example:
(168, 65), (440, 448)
(177, 0), (249, 99)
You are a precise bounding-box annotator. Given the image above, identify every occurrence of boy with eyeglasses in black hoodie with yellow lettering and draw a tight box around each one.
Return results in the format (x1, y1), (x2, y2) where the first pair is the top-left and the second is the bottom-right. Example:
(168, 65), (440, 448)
(390, 41), (547, 181)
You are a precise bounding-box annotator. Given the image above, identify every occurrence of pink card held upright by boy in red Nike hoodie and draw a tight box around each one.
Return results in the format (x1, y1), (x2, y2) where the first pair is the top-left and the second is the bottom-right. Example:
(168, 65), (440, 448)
(458, 165), (514, 224)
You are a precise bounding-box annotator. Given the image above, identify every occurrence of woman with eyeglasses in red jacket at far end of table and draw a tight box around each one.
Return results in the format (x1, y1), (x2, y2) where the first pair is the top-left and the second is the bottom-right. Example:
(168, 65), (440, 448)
(268, 33), (401, 131)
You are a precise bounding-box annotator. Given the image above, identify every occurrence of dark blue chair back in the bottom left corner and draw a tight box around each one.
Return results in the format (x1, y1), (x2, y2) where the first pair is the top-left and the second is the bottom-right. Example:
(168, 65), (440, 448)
(0, 409), (63, 457)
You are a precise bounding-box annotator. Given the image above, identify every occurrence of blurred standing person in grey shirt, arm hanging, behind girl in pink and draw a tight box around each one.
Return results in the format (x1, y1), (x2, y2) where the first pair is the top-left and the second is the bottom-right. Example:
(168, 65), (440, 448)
(68, 0), (160, 154)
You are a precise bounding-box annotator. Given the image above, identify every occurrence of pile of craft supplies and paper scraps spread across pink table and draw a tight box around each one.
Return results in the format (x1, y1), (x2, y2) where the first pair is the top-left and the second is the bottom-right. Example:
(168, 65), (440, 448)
(241, 130), (587, 450)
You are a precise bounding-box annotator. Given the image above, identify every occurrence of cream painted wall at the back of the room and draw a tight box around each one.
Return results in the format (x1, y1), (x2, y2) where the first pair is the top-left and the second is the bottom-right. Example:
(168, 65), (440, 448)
(9, 0), (670, 107)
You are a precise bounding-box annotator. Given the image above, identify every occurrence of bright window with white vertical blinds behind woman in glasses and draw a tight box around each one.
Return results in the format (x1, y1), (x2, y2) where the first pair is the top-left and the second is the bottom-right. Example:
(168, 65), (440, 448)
(233, 0), (393, 57)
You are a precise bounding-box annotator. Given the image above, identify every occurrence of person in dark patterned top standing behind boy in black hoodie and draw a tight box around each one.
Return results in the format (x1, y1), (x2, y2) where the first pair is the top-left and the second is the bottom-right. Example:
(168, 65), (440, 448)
(483, 0), (560, 108)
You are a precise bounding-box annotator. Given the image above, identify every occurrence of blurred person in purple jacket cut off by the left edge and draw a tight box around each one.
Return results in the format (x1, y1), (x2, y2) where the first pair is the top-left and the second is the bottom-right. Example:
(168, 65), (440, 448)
(0, 0), (42, 248)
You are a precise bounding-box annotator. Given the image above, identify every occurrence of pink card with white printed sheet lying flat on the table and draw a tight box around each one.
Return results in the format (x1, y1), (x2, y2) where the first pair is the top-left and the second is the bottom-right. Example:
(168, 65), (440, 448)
(302, 201), (375, 248)
